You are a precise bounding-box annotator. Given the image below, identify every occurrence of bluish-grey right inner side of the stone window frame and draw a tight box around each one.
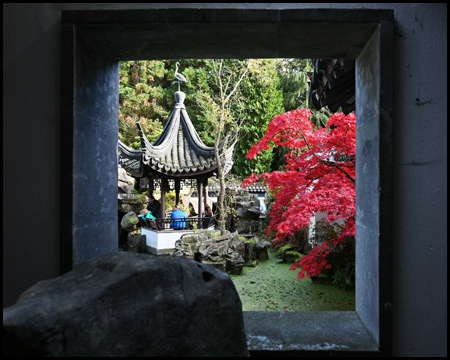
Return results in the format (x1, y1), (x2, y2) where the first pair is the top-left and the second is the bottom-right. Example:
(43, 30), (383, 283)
(355, 28), (380, 341)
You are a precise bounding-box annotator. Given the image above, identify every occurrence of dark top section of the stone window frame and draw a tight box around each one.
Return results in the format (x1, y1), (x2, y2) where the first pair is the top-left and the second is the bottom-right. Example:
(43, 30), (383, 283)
(63, 8), (386, 60)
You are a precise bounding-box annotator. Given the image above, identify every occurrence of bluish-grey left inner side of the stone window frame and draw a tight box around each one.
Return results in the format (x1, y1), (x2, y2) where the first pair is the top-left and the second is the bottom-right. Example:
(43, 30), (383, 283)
(72, 26), (119, 265)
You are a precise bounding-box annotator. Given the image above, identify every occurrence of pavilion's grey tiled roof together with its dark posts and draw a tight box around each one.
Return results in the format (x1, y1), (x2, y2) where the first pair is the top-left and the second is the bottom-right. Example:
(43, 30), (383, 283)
(119, 91), (233, 217)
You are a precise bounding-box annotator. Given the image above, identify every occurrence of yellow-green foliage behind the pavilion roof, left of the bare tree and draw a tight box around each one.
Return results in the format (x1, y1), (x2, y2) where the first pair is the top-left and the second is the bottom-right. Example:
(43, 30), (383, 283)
(119, 59), (214, 149)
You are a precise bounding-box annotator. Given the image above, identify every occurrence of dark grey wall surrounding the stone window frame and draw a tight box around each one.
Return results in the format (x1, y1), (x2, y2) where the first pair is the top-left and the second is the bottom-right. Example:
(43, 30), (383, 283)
(3, 3), (447, 356)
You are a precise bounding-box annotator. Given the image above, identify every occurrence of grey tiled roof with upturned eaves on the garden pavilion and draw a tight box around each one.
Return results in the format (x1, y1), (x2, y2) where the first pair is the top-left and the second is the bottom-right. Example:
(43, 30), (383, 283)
(119, 91), (233, 178)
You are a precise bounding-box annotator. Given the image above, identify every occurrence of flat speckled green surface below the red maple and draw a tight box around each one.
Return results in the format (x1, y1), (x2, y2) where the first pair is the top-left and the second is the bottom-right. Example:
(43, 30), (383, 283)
(230, 251), (355, 311)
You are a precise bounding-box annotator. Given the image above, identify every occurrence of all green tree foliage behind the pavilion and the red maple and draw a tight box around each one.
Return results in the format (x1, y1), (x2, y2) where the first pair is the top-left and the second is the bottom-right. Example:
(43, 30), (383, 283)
(119, 59), (329, 177)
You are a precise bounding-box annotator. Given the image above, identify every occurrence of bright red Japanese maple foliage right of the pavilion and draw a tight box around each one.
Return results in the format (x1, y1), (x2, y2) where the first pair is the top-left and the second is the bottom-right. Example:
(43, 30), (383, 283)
(243, 109), (356, 278)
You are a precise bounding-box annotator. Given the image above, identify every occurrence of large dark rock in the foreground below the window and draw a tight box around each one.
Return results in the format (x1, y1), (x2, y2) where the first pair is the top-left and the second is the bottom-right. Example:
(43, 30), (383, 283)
(3, 252), (248, 357)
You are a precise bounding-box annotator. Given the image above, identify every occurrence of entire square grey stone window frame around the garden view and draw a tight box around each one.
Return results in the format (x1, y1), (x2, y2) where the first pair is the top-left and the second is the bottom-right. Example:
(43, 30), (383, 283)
(60, 4), (394, 356)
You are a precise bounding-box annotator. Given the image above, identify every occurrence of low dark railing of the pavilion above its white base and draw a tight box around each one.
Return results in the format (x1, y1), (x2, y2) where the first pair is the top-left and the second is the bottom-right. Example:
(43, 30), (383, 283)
(139, 215), (217, 231)
